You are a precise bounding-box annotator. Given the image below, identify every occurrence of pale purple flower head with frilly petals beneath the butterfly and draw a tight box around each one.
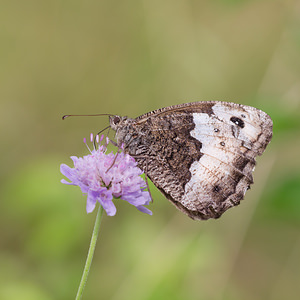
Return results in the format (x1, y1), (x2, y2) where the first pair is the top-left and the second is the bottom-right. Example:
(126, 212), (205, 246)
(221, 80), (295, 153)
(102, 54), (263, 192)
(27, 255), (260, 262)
(60, 135), (152, 216)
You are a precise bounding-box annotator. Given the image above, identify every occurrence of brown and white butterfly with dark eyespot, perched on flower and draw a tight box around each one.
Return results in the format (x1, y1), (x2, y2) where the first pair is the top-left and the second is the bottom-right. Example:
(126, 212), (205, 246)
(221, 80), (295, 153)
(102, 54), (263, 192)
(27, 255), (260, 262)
(109, 101), (273, 220)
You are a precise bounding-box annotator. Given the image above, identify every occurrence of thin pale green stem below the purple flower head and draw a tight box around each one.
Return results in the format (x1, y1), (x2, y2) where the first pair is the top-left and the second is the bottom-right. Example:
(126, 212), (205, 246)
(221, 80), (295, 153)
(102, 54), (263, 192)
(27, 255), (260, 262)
(75, 205), (103, 300)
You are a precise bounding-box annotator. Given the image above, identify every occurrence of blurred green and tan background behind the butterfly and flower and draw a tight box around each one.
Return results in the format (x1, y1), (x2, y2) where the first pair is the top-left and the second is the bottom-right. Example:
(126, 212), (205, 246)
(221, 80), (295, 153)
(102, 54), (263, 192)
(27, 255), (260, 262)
(0, 0), (300, 300)
